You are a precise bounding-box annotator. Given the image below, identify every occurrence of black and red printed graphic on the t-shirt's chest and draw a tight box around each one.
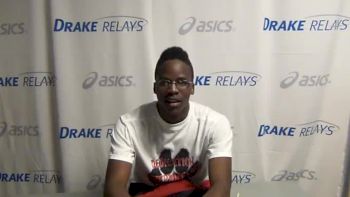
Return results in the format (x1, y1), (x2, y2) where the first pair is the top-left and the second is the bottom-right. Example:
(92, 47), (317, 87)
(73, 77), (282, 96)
(148, 148), (200, 185)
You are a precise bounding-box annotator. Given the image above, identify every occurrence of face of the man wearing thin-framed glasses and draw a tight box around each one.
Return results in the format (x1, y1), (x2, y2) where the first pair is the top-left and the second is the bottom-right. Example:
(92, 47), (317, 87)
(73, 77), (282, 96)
(153, 59), (194, 123)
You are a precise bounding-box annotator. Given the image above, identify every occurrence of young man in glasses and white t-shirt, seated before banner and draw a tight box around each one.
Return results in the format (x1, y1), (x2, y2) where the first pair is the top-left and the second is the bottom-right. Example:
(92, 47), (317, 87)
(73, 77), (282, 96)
(104, 47), (232, 197)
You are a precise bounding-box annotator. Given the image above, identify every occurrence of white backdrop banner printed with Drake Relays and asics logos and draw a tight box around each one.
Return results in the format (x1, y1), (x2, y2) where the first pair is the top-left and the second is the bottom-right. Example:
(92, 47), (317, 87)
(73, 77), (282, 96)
(0, 0), (350, 197)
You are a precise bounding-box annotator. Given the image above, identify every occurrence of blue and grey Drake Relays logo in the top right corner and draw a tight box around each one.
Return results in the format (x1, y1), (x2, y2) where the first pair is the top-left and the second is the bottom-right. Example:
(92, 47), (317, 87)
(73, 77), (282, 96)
(263, 14), (350, 32)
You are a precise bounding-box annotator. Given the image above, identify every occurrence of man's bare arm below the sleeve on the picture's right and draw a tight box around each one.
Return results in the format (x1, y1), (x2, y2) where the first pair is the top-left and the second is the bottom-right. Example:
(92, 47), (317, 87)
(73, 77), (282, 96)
(204, 157), (232, 197)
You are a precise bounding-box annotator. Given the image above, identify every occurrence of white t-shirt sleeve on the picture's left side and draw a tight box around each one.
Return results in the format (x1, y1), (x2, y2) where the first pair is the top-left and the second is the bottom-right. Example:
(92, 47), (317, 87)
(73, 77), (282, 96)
(109, 118), (135, 163)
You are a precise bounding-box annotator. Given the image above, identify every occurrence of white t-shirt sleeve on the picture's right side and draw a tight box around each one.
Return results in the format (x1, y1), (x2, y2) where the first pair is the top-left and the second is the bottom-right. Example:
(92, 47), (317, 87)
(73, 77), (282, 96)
(208, 116), (232, 159)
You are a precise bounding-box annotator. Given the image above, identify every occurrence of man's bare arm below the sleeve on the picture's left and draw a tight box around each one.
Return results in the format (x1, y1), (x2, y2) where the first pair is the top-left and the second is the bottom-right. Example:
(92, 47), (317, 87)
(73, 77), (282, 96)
(104, 159), (132, 197)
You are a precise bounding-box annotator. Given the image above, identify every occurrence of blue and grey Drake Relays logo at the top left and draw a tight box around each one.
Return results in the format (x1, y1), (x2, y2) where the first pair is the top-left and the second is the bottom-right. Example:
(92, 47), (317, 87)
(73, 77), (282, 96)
(53, 16), (148, 32)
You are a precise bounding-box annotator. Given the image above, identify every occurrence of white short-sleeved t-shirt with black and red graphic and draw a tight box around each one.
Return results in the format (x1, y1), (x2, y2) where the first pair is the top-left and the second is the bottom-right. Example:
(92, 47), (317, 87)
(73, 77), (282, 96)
(109, 101), (232, 185)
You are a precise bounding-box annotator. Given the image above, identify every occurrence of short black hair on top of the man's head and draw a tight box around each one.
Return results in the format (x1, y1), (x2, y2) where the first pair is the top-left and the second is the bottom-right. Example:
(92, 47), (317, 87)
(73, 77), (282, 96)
(154, 46), (193, 80)
